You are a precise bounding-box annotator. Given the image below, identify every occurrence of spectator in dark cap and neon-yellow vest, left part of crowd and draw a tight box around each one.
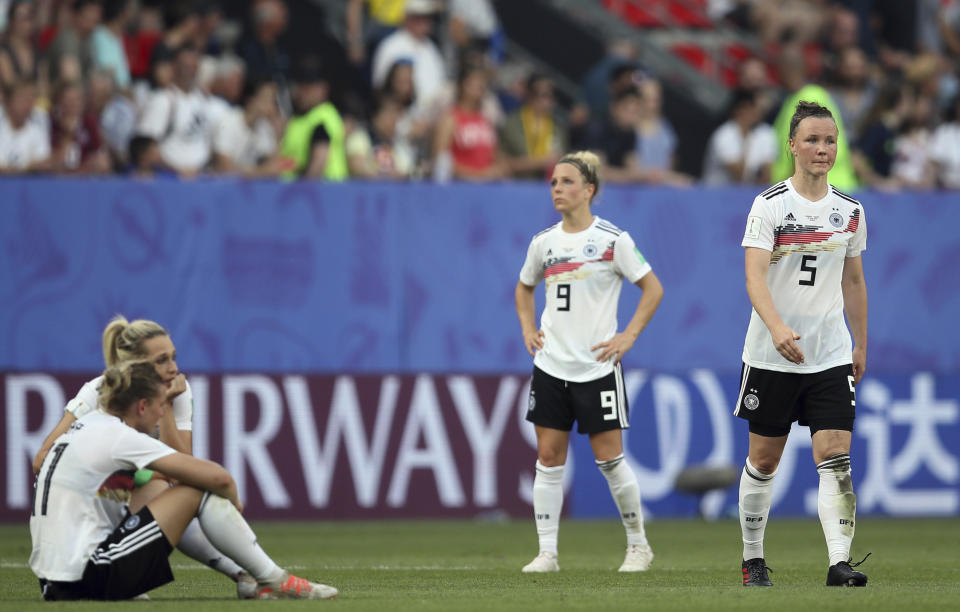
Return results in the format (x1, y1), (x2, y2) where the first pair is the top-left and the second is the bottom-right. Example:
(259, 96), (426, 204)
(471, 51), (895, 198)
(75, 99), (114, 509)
(280, 58), (349, 181)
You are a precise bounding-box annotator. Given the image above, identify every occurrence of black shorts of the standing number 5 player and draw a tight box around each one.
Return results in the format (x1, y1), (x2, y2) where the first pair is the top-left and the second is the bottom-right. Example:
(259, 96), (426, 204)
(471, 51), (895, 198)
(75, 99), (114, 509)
(733, 364), (857, 437)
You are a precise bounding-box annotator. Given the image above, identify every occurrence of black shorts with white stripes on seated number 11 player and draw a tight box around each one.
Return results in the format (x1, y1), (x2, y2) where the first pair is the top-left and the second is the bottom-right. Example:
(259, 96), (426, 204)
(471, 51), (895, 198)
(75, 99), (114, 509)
(40, 507), (173, 601)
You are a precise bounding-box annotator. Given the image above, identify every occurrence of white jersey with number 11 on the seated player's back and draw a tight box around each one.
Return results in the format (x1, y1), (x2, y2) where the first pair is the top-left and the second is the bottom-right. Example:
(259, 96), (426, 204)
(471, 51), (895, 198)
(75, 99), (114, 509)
(30, 410), (176, 582)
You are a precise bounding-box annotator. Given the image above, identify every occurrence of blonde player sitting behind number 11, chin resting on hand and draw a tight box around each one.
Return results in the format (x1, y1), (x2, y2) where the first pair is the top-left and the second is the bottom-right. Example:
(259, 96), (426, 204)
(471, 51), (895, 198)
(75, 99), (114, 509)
(33, 315), (257, 599)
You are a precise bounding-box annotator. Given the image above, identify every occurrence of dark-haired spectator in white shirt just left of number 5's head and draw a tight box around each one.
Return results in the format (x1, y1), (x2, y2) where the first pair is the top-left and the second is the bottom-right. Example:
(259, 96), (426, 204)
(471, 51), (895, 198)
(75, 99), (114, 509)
(703, 90), (777, 185)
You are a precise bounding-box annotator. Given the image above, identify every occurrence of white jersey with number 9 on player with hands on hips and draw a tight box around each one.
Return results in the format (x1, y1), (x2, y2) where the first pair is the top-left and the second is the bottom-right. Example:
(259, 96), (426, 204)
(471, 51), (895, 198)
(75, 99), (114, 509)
(520, 217), (651, 382)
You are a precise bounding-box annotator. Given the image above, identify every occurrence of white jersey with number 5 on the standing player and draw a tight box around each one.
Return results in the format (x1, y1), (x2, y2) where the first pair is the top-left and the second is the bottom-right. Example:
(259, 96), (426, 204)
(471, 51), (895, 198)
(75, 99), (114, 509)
(742, 179), (867, 373)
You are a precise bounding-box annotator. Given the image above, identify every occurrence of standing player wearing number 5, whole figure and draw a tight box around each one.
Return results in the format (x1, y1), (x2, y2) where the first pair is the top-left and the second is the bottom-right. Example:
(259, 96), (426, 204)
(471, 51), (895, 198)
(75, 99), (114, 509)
(734, 102), (867, 586)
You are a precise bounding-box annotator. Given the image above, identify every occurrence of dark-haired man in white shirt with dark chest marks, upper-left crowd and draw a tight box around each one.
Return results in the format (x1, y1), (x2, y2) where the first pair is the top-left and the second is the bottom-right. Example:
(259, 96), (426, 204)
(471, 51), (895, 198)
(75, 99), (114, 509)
(137, 45), (216, 176)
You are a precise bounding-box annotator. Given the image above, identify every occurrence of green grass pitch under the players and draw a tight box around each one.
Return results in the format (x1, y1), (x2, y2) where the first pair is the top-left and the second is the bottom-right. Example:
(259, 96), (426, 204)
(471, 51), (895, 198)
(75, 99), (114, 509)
(0, 518), (960, 612)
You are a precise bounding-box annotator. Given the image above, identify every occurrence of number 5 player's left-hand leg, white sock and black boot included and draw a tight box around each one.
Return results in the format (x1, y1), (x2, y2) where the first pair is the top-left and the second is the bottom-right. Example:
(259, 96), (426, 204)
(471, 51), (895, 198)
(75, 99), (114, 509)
(739, 432), (787, 586)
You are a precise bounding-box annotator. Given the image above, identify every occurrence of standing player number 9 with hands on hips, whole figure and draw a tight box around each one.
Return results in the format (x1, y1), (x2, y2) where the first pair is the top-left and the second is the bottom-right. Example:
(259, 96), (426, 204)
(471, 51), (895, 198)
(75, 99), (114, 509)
(516, 152), (663, 572)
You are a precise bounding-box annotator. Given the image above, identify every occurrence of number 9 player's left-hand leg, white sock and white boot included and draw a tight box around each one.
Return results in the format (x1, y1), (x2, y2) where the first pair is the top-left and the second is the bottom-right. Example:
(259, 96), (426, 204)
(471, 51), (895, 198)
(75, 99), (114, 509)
(522, 425), (570, 573)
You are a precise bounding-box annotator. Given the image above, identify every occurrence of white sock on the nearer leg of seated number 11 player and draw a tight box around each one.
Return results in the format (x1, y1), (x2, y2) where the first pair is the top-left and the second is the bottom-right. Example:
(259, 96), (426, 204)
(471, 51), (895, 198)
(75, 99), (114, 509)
(197, 493), (284, 582)
